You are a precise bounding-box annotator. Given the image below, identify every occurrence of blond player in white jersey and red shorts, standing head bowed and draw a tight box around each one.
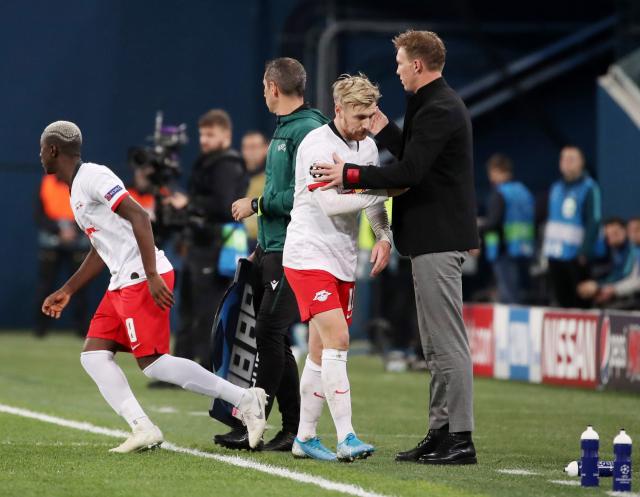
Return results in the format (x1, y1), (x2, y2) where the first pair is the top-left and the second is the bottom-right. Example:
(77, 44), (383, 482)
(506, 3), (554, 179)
(283, 74), (391, 461)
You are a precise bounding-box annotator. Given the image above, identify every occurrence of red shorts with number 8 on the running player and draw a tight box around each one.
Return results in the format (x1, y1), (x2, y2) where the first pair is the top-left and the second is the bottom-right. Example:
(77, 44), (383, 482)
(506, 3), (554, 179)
(87, 271), (175, 357)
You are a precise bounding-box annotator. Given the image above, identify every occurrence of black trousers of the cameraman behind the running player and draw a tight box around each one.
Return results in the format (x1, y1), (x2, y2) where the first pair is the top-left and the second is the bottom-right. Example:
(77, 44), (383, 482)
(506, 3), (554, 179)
(173, 246), (231, 371)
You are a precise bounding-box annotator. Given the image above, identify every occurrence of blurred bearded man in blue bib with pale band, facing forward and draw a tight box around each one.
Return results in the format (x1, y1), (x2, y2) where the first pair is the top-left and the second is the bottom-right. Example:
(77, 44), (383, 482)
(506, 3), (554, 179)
(543, 145), (602, 307)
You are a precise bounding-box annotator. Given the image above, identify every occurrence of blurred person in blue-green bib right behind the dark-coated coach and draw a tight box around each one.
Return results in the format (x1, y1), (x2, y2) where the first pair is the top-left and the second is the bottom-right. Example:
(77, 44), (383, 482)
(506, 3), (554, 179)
(480, 154), (535, 304)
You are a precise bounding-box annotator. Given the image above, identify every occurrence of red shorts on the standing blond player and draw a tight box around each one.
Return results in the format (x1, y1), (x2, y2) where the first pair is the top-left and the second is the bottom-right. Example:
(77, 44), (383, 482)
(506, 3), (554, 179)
(284, 267), (356, 325)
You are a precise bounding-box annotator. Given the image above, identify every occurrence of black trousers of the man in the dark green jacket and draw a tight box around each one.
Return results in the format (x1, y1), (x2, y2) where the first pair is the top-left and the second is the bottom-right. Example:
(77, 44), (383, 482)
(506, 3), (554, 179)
(254, 247), (300, 433)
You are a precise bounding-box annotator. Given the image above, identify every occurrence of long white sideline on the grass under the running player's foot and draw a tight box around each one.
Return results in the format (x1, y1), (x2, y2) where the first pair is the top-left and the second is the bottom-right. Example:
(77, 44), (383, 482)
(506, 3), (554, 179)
(0, 404), (389, 497)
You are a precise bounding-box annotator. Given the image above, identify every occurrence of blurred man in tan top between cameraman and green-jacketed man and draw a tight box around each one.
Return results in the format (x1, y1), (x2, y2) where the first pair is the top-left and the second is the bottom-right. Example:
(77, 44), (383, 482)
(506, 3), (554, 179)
(241, 131), (269, 252)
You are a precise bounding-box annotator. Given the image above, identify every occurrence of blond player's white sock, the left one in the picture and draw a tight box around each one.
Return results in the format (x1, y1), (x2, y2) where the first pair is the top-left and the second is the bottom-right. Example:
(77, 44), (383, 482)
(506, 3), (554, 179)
(297, 356), (324, 441)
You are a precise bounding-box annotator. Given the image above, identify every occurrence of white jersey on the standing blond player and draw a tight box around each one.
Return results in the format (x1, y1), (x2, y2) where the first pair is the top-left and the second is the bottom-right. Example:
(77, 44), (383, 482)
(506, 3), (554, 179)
(282, 123), (387, 281)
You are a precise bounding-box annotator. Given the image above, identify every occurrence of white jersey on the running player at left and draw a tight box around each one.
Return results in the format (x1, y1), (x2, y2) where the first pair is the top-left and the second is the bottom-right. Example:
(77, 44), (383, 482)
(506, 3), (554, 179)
(70, 162), (173, 290)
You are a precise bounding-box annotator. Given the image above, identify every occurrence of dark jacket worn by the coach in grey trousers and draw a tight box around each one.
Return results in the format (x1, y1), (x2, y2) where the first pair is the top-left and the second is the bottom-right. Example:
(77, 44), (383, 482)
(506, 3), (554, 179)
(343, 78), (478, 256)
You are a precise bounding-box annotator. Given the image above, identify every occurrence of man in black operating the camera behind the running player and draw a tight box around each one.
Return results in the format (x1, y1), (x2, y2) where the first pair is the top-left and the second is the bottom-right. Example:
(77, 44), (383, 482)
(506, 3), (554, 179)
(167, 109), (248, 370)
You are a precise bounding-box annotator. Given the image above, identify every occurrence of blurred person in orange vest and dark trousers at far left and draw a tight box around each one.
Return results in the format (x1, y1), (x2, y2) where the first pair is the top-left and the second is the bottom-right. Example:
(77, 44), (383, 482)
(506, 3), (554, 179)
(34, 175), (89, 337)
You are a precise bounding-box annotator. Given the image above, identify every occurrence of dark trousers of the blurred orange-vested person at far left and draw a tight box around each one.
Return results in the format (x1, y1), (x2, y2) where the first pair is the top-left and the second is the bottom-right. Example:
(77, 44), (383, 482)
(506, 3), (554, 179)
(34, 248), (90, 336)
